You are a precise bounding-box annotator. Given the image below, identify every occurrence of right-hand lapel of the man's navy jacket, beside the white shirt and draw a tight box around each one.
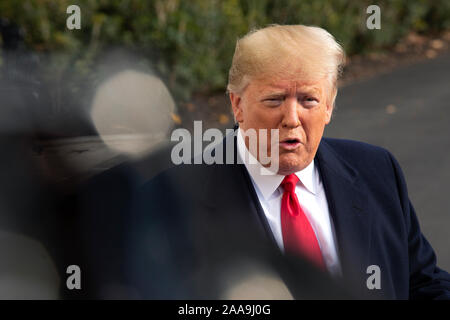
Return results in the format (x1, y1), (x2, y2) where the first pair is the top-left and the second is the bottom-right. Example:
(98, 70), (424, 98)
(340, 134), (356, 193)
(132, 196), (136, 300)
(315, 139), (371, 287)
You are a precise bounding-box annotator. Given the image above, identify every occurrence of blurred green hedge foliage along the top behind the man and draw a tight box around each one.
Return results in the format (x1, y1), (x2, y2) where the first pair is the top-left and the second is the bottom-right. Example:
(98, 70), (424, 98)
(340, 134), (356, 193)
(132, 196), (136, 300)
(0, 0), (450, 100)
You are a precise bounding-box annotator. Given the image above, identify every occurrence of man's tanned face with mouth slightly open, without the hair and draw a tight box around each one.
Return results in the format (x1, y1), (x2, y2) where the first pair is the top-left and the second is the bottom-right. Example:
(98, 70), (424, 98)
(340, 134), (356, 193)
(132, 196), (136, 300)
(230, 78), (333, 175)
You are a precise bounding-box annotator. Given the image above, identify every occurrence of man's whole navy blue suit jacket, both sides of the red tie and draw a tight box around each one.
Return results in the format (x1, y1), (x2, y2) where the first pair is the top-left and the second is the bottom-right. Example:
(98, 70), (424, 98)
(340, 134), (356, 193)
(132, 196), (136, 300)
(129, 137), (450, 299)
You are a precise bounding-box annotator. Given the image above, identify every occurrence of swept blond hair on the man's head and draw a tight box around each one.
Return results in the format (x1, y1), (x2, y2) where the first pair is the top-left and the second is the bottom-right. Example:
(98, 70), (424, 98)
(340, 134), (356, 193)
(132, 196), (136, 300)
(227, 25), (345, 102)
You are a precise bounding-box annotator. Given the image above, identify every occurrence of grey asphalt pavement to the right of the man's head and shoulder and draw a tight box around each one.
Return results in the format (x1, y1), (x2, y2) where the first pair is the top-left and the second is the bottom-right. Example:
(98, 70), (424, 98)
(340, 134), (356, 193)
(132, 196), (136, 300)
(325, 53), (450, 271)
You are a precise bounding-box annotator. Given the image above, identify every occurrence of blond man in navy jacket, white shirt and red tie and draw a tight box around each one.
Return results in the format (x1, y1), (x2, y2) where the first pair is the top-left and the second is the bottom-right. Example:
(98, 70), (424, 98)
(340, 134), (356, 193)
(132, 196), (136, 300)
(129, 25), (450, 299)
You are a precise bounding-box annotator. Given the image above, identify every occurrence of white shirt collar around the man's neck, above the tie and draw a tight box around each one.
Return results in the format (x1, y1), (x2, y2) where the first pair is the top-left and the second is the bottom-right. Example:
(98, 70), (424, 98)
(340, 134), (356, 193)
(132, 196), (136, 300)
(237, 128), (318, 200)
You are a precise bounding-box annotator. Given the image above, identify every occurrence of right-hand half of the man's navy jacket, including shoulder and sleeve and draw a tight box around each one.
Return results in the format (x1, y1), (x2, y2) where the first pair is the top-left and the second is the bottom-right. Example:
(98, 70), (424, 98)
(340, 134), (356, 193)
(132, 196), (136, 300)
(316, 138), (450, 299)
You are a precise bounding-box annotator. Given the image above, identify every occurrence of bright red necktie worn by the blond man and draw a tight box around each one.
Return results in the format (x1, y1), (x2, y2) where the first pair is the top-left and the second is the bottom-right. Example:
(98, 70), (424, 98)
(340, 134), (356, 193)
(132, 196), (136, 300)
(281, 174), (325, 270)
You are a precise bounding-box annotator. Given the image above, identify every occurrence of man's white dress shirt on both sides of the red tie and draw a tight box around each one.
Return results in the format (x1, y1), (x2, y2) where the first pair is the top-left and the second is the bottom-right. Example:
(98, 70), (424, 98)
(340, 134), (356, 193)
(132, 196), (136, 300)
(237, 129), (341, 275)
